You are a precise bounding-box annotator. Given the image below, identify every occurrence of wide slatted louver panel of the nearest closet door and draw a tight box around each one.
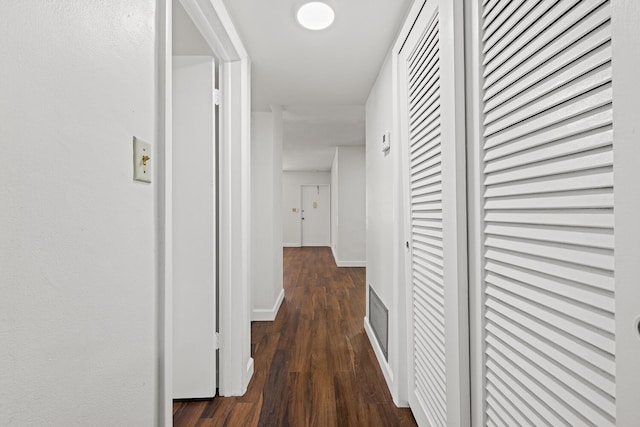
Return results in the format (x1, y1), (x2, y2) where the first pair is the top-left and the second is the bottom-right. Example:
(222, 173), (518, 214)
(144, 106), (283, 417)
(474, 0), (616, 427)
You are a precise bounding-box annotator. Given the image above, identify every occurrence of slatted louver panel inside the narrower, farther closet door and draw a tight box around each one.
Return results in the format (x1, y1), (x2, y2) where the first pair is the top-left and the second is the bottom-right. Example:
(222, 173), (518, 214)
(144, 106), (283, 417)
(407, 13), (447, 426)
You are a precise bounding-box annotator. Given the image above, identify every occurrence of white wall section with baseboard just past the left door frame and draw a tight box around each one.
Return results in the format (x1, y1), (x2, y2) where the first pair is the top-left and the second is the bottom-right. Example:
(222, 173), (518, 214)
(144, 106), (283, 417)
(251, 112), (284, 320)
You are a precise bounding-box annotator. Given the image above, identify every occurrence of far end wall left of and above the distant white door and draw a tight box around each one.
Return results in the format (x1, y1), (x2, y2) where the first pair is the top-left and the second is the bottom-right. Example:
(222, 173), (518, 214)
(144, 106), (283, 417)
(282, 171), (333, 247)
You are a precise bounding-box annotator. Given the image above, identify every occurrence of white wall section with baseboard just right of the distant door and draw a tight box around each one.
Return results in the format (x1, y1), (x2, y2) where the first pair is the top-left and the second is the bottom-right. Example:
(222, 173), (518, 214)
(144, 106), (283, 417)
(331, 146), (366, 267)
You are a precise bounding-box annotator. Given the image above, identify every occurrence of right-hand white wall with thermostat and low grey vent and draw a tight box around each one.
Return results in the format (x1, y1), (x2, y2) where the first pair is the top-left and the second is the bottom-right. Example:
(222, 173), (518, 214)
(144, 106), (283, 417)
(365, 51), (408, 406)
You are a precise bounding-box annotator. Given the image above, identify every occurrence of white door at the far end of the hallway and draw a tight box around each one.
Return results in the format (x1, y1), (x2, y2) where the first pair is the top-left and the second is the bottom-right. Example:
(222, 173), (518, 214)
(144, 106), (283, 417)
(300, 185), (331, 246)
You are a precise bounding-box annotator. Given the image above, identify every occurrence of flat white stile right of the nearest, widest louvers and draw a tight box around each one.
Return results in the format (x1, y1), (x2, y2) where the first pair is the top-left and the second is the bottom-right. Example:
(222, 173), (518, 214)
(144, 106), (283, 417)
(611, 0), (640, 426)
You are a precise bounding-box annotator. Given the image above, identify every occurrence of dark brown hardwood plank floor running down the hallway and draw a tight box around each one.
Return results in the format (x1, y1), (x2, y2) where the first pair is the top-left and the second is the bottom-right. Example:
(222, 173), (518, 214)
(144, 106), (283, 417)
(173, 248), (416, 427)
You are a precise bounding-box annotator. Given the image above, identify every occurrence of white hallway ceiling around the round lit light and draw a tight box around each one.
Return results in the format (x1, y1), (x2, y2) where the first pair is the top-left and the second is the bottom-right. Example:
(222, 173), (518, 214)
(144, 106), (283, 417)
(224, 0), (412, 170)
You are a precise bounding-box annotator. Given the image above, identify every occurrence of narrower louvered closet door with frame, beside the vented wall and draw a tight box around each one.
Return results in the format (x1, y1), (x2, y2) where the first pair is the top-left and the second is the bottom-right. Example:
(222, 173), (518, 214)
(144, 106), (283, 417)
(398, 0), (469, 426)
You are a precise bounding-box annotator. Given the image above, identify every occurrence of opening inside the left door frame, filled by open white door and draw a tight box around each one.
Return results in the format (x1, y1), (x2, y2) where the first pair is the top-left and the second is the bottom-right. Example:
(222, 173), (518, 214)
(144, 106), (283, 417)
(172, 0), (218, 399)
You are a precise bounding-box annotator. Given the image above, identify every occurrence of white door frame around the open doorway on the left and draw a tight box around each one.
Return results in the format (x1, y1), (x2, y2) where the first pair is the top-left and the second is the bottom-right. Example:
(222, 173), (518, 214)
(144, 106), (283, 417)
(155, 0), (253, 426)
